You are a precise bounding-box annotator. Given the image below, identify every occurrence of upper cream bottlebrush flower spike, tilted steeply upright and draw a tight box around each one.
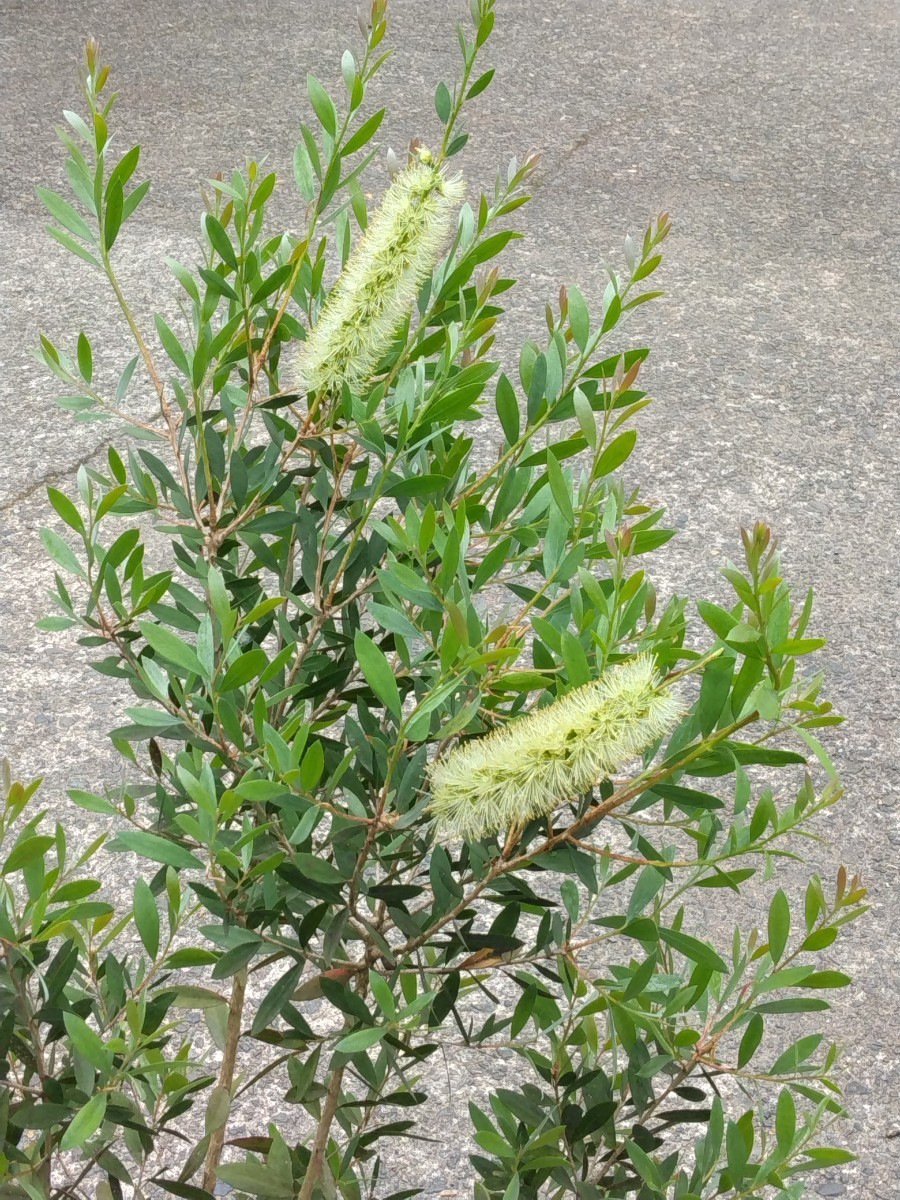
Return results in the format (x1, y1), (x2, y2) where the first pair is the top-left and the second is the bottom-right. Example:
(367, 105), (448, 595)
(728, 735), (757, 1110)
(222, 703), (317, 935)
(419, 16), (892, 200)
(296, 151), (464, 394)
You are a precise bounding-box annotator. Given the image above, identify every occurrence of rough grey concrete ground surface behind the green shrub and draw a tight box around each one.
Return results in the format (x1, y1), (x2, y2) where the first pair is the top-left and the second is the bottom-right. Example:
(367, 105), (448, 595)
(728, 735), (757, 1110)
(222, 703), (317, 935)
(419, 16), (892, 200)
(0, 0), (900, 1200)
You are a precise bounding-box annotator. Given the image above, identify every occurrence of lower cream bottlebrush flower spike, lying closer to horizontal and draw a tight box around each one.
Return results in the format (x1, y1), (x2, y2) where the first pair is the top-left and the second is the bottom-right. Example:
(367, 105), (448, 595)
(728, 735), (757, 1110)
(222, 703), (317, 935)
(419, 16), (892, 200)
(430, 654), (684, 841)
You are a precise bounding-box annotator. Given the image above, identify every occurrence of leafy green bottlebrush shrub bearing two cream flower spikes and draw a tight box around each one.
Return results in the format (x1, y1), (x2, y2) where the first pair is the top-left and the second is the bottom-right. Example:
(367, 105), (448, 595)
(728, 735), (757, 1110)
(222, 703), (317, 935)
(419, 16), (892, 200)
(21, 0), (864, 1200)
